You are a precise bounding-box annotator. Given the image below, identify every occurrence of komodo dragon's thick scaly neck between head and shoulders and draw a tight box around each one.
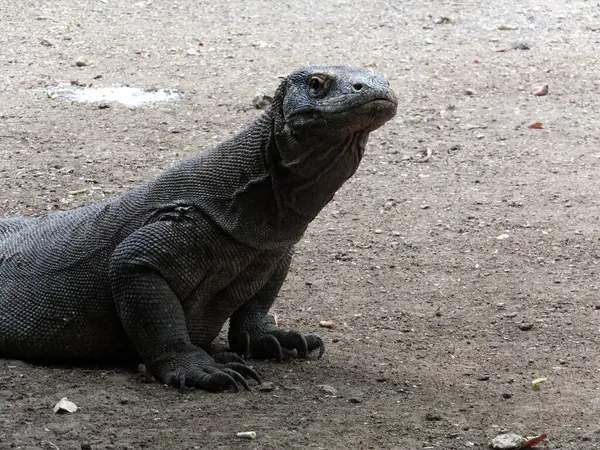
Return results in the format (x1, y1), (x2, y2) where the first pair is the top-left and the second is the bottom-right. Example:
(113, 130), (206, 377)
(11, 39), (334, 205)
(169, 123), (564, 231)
(144, 110), (368, 249)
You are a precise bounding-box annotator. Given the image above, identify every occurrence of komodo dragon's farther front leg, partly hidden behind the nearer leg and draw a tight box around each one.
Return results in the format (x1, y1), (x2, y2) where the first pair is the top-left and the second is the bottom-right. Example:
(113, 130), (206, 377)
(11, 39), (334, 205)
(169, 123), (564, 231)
(229, 249), (325, 362)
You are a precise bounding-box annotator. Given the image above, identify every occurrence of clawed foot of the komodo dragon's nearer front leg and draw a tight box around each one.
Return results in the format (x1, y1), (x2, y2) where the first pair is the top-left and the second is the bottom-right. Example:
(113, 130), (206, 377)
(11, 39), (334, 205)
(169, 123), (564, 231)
(147, 347), (261, 392)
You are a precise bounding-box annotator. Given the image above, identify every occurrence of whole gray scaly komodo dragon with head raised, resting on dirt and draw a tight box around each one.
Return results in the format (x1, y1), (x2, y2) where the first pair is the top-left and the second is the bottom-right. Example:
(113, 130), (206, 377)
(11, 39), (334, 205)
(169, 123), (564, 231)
(0, 67), (397, 391)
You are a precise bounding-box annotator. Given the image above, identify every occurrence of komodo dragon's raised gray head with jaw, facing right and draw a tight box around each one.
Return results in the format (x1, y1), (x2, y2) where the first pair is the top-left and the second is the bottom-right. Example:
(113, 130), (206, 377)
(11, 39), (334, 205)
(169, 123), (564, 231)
(272, 66), (398, 177)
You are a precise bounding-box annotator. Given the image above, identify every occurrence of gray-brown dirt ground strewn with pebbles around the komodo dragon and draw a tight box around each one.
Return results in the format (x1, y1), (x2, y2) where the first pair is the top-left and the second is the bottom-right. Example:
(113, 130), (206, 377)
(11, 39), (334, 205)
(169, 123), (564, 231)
(0, 0), (600, 450)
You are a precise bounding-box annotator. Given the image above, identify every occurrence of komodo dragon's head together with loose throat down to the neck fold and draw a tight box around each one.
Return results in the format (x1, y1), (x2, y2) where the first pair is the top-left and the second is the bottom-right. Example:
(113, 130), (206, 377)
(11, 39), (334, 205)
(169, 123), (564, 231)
(267, 66), (398, 220)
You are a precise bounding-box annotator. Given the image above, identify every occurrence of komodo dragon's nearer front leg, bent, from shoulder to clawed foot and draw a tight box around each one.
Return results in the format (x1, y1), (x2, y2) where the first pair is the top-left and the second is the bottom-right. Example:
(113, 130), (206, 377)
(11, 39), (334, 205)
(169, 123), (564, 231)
(110, 218), (260, 391)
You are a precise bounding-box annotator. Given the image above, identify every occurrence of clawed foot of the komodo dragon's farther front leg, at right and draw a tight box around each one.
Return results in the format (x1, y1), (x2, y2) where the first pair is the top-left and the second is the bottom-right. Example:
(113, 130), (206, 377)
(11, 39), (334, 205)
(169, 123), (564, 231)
(229, 316), (325, 362)
